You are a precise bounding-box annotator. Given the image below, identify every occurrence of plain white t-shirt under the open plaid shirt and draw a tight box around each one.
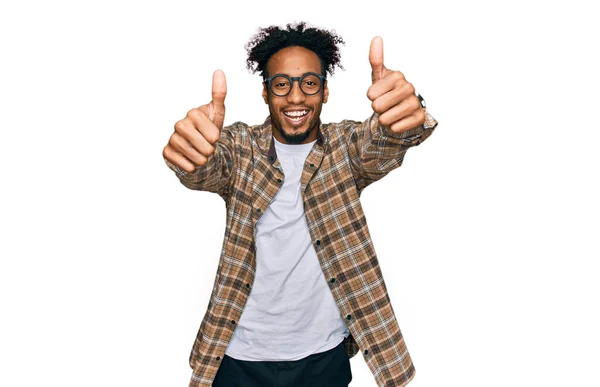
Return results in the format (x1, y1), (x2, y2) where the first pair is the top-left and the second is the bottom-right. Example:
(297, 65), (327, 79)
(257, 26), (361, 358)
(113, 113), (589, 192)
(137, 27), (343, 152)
(225, 137), (350, 361)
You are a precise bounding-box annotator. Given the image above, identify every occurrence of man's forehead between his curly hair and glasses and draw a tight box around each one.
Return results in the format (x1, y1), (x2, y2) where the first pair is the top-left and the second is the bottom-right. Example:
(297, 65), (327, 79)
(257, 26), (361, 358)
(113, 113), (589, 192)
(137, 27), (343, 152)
(267, 46), (321, 77)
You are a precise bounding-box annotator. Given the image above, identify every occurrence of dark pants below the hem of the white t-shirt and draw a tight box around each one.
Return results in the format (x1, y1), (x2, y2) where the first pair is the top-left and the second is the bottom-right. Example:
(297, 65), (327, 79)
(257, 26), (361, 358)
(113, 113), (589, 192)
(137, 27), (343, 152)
(212, 343), (352, 387)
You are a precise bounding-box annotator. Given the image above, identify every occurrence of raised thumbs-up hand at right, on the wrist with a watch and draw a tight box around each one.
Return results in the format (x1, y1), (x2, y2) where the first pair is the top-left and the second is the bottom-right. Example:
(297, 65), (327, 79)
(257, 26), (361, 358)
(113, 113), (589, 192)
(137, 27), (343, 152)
(367, 36), (425, 133)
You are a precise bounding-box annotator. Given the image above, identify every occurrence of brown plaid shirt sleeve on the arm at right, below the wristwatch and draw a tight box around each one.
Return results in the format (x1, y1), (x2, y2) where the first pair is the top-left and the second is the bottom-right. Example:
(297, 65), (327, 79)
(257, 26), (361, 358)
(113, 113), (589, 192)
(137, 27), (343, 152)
(348, 112), (438, 191)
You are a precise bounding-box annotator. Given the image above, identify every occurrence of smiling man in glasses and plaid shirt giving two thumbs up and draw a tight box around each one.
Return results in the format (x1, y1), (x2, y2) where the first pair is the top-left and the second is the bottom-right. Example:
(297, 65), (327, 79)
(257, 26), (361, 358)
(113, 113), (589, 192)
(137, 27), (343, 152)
(163, 23), (437, 387)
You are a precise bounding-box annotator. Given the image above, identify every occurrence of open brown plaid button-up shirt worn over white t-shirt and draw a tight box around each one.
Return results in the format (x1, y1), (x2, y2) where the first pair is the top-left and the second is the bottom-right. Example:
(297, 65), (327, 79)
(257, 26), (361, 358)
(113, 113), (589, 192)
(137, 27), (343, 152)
(165, 113), (437, 387)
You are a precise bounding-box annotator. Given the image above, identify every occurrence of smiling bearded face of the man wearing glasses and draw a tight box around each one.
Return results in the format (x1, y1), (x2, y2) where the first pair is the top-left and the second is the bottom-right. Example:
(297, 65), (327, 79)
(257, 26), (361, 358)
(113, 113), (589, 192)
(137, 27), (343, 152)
(262, 46), (329, 144)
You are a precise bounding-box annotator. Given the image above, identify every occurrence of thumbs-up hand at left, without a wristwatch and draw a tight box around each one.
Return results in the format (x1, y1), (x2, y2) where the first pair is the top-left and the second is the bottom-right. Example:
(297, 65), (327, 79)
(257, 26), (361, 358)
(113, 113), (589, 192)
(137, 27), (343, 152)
(163, 70), (227, 172)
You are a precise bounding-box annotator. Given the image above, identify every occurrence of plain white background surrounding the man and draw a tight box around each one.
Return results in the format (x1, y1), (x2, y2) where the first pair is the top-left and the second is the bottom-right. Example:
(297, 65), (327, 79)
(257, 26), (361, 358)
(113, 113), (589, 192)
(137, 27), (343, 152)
(0, 1), (600, 387)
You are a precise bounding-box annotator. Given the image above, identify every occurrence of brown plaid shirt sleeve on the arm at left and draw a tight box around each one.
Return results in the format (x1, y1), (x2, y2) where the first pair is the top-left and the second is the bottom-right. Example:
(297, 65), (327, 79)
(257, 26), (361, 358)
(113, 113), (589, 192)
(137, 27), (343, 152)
(165, 127), (236, 201)
